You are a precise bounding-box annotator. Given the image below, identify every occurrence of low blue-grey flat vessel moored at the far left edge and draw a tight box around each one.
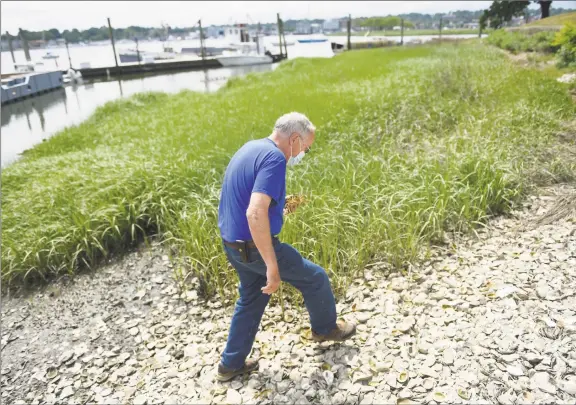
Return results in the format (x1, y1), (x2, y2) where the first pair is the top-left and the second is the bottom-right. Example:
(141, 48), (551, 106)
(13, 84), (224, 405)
(0, 70), (63, 104)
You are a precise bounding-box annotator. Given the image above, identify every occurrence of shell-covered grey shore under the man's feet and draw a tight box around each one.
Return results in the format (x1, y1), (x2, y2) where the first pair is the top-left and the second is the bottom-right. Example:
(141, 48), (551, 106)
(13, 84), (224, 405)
(1, 188), (576, 404)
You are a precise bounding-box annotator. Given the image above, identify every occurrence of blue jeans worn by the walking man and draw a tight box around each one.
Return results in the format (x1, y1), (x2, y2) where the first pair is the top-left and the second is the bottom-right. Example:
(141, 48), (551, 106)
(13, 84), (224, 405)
(222, 239), (336, 369)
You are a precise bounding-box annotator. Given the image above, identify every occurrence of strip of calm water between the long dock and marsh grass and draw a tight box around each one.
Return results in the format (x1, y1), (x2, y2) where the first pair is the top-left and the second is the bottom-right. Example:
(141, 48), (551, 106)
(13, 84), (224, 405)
(1, 65), (277, 167)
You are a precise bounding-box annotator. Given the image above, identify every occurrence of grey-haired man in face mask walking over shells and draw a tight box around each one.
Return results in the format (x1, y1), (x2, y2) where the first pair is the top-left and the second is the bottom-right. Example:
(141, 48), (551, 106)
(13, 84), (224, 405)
(218, 112), (356, 381)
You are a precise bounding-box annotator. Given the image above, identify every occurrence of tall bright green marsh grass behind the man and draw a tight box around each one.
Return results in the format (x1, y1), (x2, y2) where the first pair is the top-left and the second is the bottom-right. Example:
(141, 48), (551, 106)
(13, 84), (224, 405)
(2, 44), (576, 293)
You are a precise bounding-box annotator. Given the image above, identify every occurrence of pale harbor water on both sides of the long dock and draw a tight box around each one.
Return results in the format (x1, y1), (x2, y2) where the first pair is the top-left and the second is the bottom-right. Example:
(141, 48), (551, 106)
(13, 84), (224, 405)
(1, 35), (482, 167)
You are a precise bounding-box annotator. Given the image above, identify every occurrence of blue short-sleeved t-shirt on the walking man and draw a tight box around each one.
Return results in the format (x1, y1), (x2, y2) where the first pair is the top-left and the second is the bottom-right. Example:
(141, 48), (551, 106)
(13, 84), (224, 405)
(218, 138), (286, 242)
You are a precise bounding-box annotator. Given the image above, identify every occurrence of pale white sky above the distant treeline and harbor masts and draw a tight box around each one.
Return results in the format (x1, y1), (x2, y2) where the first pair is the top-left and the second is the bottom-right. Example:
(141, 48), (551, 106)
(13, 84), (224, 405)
(0, 0), (576, 34)
